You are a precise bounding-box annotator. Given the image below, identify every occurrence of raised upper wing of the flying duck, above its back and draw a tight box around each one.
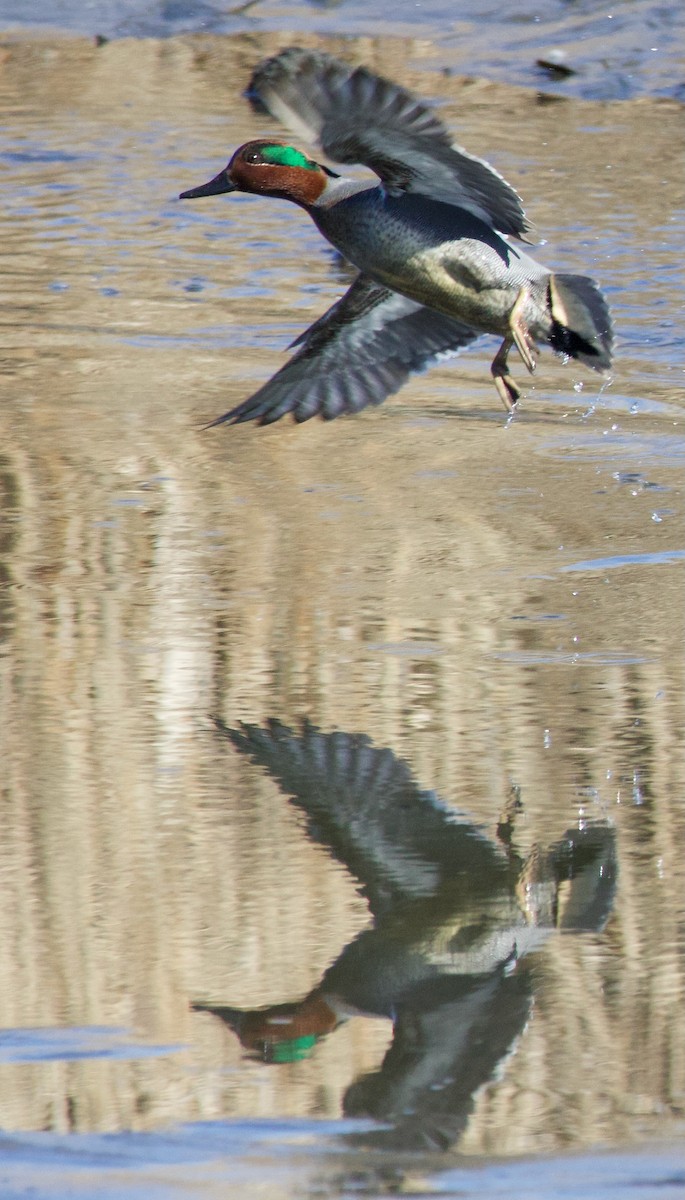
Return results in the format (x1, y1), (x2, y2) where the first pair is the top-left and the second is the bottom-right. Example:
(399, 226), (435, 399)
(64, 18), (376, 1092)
(247, 47), (530, 241)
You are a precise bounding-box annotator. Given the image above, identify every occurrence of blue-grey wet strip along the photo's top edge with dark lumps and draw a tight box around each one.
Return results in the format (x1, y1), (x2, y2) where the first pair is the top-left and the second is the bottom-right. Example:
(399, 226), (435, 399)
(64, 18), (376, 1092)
(0, 0), (685, 100)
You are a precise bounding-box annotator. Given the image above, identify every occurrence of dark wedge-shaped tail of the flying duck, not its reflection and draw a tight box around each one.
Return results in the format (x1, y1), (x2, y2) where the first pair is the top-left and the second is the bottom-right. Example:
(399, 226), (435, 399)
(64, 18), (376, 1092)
(547, 274), (613, 371)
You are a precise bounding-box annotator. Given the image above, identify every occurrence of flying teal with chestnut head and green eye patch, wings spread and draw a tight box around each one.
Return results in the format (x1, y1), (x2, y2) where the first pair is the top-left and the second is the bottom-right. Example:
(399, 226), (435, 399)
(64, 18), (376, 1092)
(181, 47), (612, 425)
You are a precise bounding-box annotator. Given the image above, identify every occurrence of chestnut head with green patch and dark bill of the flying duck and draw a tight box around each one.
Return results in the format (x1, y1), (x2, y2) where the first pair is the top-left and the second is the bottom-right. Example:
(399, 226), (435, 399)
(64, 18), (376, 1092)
(179, 142), (334, 208)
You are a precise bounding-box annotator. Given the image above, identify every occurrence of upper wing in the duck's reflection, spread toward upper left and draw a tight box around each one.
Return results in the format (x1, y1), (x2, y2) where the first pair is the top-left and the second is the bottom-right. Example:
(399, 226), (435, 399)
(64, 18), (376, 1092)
(217, 721), (507, 917)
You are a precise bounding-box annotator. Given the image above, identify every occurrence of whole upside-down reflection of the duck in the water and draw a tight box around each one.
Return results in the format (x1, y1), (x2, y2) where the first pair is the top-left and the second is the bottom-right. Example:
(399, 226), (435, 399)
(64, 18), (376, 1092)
(193, 721), (617, 1148)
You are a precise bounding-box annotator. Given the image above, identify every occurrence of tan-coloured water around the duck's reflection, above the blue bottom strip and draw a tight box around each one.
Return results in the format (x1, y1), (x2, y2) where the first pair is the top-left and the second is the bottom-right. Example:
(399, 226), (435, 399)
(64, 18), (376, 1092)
(0, 36), (685, 1152)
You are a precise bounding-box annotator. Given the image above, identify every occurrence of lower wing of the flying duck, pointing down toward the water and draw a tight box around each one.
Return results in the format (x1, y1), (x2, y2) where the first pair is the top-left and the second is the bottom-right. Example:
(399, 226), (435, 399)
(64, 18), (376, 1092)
(206, 275), (479, 425)
